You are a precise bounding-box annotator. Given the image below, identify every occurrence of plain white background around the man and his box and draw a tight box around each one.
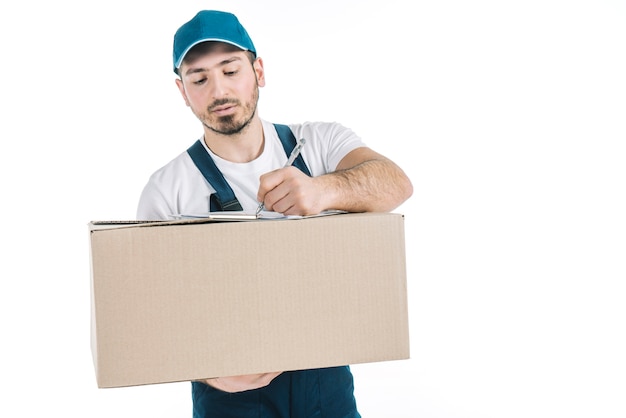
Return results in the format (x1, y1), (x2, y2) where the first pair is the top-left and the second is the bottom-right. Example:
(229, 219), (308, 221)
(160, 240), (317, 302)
(0, 0), (626, 418)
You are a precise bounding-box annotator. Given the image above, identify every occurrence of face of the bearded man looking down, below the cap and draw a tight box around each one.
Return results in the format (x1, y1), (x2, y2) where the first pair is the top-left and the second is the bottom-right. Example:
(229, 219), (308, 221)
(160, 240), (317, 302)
(176, 43), (265, 135)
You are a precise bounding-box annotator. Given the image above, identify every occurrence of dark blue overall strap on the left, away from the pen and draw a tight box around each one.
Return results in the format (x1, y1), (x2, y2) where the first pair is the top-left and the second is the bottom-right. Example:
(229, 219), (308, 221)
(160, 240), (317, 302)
(187, 140), (243, 212)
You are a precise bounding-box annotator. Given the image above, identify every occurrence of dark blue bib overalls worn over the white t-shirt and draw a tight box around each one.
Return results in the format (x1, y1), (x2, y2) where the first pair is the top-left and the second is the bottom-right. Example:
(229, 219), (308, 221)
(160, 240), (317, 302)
(187, 124), (361, 418)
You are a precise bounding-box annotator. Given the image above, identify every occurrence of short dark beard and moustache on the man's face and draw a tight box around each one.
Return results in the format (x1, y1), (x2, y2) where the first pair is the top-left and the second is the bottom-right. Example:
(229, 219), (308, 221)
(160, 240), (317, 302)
(198, 86), (259, 135)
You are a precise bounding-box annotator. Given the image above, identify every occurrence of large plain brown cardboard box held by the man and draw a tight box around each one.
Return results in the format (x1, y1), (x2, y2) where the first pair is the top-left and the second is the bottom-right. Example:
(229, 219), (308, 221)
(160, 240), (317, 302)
(89, 213), (409, 388)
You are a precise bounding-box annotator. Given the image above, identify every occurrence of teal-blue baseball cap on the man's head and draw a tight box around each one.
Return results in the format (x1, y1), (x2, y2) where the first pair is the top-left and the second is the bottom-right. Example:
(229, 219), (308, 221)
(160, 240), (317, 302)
(174, 10), (256, 74)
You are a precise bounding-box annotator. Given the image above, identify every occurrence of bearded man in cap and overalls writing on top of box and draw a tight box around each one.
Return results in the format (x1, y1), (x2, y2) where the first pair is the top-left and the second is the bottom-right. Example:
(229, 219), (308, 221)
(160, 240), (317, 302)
(138, 11), (413, 418)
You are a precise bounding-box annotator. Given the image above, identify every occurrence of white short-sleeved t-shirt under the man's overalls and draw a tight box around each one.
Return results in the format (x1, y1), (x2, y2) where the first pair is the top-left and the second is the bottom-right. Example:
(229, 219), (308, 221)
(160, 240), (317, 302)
(137, 121), (365, 220)
